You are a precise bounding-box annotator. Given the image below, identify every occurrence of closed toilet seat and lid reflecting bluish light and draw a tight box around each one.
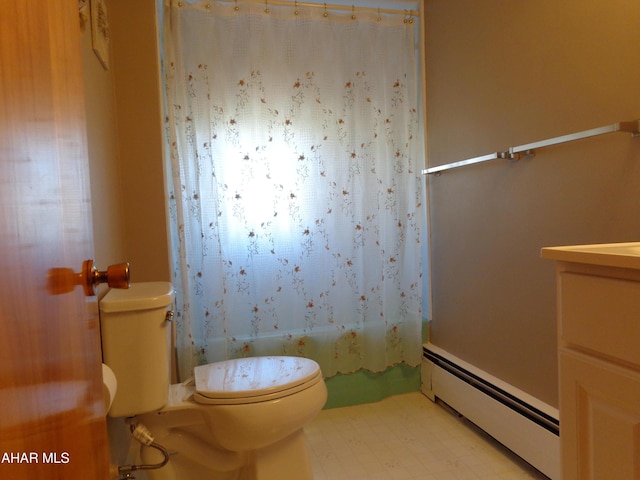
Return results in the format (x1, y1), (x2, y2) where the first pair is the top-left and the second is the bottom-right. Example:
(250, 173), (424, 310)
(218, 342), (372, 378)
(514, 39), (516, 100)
(193, 356), (322, 405)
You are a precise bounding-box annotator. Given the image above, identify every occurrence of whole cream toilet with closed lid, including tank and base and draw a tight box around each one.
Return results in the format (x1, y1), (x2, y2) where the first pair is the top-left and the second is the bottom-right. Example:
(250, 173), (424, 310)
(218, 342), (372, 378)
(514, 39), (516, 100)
(100, 282), (327, 480)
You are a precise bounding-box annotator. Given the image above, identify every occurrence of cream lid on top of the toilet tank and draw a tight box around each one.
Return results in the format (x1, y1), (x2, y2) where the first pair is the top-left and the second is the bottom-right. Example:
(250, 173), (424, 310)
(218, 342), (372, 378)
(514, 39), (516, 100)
(100, 282), (174, 313)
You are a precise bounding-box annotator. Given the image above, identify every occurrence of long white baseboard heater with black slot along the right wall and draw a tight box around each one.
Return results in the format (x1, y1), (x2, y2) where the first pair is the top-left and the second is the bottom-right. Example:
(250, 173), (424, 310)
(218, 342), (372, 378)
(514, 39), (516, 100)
(422, 343), (560, 480)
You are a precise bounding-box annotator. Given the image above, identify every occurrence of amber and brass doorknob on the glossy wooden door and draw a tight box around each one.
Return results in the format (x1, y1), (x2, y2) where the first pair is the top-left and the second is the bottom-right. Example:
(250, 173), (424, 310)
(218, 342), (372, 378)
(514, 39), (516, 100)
(47, 260), (130, 297)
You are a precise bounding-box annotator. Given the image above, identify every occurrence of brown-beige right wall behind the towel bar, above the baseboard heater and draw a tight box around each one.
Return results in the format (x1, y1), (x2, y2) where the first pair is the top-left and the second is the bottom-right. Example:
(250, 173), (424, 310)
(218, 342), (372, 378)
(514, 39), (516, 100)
(425, 0), (640, 405)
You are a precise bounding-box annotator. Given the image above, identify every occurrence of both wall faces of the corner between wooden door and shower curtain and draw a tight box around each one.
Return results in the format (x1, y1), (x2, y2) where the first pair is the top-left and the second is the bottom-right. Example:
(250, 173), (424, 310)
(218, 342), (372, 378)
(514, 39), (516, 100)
(83, 0), (170, 282)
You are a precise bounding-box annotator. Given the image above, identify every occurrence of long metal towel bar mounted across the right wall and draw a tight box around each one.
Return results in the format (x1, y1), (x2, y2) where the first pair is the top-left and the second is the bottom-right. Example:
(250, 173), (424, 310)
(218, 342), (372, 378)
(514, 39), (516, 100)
(422, 120), (640, 175)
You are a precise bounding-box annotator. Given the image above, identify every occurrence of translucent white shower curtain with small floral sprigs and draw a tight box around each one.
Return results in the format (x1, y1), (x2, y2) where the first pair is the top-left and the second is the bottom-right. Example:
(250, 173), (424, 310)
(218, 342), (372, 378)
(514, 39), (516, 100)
(164, 1), (424, 378)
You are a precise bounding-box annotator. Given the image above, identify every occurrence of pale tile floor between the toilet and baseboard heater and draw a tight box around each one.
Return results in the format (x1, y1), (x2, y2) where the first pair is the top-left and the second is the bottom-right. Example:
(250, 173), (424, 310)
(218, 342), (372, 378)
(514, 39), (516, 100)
(305, 392), (547, 480)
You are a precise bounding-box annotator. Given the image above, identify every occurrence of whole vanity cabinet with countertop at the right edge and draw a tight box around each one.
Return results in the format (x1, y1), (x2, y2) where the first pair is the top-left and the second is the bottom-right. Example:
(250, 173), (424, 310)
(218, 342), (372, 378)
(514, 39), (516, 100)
(542, 243), (640, 480)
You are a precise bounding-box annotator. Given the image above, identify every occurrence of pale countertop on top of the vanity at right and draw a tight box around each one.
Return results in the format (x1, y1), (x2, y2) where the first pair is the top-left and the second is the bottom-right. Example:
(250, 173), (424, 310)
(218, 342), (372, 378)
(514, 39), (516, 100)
(541, 242), (640, 270)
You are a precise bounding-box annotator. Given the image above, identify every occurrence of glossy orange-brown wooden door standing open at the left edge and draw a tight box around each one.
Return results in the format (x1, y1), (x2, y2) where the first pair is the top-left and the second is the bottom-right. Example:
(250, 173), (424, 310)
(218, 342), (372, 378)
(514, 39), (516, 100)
(0, 0), (108, 480)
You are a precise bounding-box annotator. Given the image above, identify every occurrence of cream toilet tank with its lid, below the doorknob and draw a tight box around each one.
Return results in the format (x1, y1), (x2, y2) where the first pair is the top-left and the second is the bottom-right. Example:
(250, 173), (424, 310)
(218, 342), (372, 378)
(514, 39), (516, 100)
(100, 282), (174, 417)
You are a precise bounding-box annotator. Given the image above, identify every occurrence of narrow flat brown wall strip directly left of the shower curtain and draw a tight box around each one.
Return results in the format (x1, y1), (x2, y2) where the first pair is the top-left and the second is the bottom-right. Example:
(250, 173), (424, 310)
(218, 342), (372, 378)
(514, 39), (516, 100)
(109, 0), (170, 281)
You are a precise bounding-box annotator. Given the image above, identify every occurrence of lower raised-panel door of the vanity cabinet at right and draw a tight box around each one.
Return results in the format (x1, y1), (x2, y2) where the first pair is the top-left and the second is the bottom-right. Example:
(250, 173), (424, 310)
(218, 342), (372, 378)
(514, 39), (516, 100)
(560, 350), (640, 480)
